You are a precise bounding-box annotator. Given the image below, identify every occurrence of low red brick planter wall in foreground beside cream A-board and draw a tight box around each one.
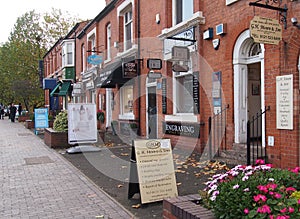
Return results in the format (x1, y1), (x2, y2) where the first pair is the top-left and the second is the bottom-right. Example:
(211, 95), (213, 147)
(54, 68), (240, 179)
(163, 194), (216, 219)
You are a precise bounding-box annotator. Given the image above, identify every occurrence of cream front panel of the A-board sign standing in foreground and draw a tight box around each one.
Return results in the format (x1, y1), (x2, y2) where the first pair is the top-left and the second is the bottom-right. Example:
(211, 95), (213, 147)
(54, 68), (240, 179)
(134, 139), (178, 204)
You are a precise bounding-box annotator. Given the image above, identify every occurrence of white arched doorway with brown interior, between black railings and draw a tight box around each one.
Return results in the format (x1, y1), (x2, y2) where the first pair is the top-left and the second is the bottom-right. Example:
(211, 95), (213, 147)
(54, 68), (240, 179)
(233, 30), (265, 146)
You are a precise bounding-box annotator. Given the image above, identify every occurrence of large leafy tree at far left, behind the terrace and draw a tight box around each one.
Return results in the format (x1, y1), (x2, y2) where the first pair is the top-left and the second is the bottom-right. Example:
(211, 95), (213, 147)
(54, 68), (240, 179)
(0, 8), (78, 110)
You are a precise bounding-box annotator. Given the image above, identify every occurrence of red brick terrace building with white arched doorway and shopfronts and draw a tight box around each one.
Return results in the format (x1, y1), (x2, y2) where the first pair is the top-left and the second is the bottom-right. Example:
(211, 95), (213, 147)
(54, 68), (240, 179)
(45, 0), (300, 168)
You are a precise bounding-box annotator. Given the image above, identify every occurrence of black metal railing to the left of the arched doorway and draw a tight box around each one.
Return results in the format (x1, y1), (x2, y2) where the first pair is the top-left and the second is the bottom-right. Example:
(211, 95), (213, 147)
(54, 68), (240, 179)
(208, 105), (229, 159)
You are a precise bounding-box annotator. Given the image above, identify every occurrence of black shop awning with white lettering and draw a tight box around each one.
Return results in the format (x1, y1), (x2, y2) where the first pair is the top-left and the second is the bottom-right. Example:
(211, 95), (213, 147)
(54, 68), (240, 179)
(96, 61), (130, 88)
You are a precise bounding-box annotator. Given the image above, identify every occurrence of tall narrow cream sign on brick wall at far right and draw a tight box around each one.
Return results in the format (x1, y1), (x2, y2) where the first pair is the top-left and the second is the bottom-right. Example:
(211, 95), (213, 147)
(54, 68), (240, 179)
(276, 75), (293, 130)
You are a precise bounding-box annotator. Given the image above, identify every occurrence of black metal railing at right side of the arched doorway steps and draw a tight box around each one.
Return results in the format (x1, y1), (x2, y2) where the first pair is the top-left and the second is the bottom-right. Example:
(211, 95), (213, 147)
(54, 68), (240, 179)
(247, 106), (270, 165)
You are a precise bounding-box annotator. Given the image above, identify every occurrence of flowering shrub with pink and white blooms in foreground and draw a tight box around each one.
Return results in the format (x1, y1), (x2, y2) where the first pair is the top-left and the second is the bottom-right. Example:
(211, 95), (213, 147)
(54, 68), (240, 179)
(200, 161), (300, 219)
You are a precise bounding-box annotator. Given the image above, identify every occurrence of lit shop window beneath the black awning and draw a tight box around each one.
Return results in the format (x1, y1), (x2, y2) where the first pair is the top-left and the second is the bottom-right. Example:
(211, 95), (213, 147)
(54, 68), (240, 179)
(120, 85), (133, 115)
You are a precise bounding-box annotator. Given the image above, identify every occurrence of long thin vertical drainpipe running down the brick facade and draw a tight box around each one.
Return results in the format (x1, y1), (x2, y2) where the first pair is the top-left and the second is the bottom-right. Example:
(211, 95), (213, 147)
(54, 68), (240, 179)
(137, 0), (141, 136)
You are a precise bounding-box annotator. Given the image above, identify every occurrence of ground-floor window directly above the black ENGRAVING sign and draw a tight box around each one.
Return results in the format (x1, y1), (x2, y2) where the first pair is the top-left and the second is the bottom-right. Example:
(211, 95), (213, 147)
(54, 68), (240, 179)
(175, 73), (194, 113)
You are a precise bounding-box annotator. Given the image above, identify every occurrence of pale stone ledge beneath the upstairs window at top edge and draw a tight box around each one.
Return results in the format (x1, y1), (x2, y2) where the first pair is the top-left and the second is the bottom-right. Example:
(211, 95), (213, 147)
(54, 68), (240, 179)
(158, 11), (205, 40)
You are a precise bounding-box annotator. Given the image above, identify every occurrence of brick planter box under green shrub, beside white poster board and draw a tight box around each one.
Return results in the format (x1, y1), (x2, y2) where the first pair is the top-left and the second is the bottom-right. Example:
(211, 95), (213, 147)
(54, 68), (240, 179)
(44, 128), (72, 149)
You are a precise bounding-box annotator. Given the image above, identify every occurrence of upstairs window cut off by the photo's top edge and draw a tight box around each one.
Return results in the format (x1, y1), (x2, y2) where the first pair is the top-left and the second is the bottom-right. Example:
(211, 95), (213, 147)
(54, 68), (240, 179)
(173, 0), (194, 25)
